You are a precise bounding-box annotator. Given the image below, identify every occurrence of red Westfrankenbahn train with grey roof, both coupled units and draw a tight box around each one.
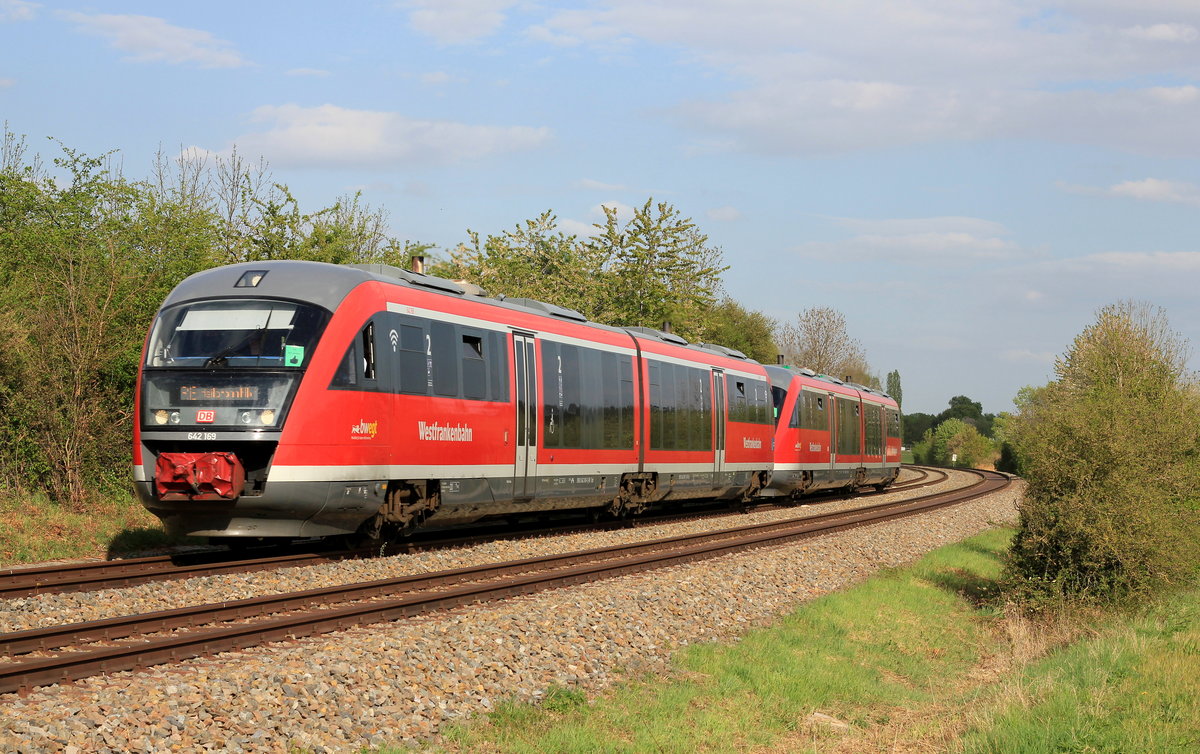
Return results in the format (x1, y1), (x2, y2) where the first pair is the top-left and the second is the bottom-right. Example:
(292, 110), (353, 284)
(133, 261), (900, 538)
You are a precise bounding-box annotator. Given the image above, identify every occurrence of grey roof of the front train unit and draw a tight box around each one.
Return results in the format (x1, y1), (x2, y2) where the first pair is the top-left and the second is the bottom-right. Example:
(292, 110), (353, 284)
(162, 259), (760, 366)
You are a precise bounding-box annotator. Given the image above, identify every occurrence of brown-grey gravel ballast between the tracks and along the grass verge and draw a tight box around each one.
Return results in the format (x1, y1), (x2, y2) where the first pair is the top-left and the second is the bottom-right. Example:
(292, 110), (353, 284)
(0, 473), (1020, 753)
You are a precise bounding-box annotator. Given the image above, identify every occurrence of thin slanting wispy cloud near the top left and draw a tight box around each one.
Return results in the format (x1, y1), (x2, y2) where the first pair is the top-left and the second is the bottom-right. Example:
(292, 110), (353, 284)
(59, 11), (248, 68)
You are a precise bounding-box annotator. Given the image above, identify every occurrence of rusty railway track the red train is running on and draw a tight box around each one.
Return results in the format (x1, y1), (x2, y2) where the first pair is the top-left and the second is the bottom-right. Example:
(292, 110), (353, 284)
(0, 468), (947, 599)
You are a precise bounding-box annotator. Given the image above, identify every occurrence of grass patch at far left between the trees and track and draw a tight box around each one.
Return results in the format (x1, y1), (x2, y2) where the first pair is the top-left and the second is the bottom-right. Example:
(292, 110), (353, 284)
(0, 491), (189, 568)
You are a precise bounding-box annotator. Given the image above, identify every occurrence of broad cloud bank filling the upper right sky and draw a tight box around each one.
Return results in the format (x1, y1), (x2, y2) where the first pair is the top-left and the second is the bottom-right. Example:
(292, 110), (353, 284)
(530, 0), (1200, 156)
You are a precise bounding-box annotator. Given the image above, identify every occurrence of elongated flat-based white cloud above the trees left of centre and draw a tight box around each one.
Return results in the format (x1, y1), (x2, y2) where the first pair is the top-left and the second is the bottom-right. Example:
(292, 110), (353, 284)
(226, 104), (551, 168)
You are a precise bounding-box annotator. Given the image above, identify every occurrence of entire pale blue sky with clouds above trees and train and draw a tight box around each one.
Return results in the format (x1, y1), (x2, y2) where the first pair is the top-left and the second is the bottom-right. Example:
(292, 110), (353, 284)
(0, 0), (1200, 413)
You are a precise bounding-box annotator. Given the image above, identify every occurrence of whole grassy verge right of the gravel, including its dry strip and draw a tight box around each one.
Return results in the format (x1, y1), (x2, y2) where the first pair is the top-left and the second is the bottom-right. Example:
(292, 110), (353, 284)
(432, 529), (1200, 753)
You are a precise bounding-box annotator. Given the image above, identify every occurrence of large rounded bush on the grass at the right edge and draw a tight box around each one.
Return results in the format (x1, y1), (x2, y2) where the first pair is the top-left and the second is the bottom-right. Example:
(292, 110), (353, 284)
(1007, 303), (1200, 606)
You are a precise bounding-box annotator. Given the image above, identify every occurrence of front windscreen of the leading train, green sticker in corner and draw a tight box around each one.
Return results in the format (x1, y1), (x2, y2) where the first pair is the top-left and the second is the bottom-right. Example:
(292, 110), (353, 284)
(146, 299), (329, 369)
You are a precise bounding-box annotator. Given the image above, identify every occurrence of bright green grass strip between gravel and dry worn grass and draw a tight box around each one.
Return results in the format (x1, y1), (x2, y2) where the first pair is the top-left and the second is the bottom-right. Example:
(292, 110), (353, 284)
(432, 529), (1012, 752)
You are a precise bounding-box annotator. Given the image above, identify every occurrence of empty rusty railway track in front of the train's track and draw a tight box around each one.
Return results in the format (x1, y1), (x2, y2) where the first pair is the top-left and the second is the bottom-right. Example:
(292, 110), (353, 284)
(0, 472), (1009, 693)
